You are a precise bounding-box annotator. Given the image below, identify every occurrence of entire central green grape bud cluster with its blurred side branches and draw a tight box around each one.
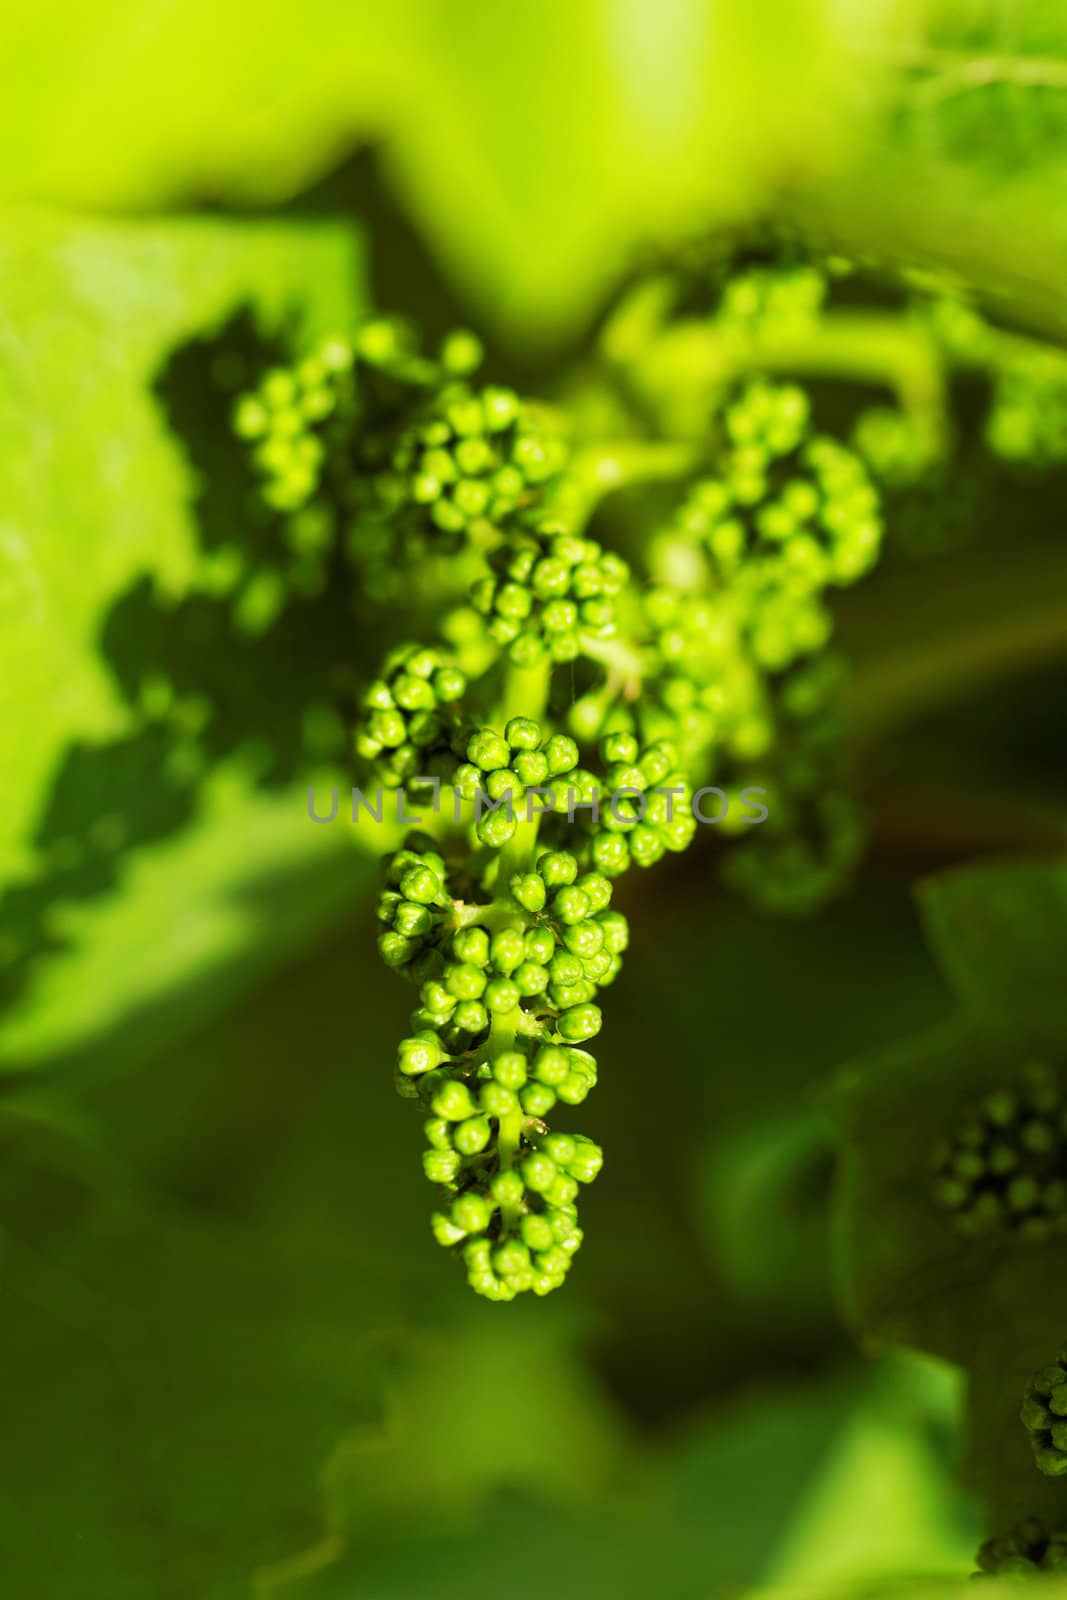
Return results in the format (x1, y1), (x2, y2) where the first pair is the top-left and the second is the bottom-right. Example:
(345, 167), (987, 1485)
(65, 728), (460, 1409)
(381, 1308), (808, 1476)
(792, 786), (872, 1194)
(235, 284), (881, 1299)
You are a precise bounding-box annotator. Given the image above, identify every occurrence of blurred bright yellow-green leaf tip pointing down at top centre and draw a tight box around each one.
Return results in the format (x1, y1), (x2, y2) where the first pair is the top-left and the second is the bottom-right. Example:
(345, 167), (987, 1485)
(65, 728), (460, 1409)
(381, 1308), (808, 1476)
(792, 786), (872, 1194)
(379, 0), (864, 341)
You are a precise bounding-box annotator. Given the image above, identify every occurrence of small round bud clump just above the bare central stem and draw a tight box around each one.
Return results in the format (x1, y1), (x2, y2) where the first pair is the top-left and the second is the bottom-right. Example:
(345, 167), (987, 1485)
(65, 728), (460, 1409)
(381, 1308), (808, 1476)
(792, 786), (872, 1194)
(470, 518), (630, 667)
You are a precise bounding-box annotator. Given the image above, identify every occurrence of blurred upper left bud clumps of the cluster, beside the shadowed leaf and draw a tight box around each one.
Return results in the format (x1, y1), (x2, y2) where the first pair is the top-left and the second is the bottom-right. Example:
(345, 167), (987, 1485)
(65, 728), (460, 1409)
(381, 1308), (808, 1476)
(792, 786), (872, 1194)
(234, 317), (568, 590)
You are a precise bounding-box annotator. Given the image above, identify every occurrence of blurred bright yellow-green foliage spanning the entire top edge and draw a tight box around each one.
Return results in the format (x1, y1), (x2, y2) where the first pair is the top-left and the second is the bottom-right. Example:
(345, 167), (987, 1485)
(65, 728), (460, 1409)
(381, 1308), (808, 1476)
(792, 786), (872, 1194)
(10, 0), (1067, 339)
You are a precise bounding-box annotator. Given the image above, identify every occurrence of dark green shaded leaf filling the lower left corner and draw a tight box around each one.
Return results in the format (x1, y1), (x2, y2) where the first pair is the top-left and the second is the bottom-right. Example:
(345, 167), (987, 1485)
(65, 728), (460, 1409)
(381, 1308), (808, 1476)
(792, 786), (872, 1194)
(0, 921), (457, 1600)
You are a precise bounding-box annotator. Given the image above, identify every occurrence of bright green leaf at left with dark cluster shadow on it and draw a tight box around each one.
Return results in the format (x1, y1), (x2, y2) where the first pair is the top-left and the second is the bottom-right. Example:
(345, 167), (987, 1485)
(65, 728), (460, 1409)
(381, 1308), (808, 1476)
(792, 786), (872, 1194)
(0, 216), (375, 1070)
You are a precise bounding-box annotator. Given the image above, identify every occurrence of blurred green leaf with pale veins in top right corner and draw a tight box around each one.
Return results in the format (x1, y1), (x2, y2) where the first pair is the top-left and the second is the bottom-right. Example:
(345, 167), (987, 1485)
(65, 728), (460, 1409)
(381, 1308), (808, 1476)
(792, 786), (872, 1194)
(799, 0), (1067, 338)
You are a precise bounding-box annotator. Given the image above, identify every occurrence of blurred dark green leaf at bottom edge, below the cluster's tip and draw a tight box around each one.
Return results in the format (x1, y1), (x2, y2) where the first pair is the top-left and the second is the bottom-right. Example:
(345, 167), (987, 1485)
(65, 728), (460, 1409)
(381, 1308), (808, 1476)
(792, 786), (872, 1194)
(254, 1356), (856, 1600)
